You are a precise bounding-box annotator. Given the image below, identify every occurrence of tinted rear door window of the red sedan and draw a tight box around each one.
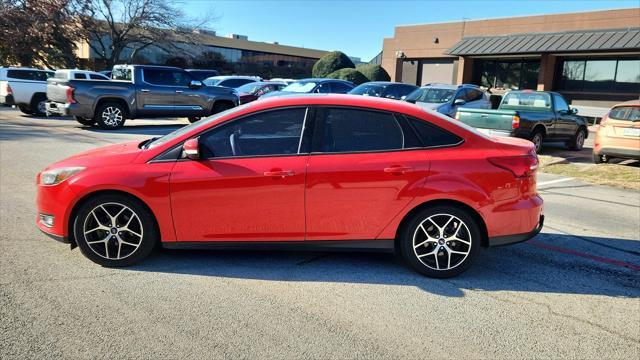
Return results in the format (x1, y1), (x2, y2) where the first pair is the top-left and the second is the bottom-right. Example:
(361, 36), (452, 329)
(320, 108), (403, 153)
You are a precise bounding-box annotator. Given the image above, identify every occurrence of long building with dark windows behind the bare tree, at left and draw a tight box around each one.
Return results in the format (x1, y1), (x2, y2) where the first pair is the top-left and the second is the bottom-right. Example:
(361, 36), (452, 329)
(78, 31), (327, 78)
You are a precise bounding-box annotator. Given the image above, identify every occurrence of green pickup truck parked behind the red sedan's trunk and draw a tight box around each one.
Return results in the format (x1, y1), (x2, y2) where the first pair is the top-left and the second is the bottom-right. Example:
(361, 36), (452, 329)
(455, 90), (589, 153)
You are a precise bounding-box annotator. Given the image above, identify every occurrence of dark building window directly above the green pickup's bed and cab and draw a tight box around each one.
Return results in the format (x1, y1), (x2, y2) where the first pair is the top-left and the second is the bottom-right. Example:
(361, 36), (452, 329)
(474, 59), (540, 90)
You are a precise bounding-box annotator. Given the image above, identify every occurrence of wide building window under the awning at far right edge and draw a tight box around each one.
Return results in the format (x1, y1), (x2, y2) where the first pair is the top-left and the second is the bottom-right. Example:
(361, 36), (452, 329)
(558, 59), (640, 93)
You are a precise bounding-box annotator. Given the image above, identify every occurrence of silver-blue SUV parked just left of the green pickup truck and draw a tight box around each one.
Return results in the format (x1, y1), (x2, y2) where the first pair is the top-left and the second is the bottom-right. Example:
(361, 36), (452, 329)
(405, 84), (491, 117)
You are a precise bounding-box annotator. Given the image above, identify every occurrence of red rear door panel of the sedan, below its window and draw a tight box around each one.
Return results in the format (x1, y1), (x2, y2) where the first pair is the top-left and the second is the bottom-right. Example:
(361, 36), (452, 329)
(306, 150), (428, 240)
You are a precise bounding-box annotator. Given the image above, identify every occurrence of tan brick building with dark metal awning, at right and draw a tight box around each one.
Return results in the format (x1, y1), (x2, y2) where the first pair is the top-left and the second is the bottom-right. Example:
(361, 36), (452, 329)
(382, 8), (640, 116)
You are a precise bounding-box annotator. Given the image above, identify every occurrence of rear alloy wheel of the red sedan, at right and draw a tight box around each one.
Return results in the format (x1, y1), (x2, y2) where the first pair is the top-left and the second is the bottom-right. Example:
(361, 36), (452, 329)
(413, 214), (473, 271)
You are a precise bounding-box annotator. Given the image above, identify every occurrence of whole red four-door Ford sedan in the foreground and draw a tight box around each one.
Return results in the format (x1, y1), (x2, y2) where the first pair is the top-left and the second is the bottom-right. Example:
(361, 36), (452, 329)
(37, 95), (544, 277)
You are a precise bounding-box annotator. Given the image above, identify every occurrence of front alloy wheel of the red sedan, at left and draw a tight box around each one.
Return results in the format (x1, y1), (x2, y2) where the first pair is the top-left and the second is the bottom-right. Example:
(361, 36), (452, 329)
(82, 202), (144, 260)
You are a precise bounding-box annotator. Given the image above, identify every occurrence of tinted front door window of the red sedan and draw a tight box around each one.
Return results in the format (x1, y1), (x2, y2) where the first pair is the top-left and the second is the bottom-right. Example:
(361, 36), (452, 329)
(199, 108), (306, 158)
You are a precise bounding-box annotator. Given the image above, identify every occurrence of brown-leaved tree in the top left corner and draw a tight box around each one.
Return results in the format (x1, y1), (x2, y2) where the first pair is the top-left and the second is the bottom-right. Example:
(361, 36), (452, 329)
(0, 0), (80, 69)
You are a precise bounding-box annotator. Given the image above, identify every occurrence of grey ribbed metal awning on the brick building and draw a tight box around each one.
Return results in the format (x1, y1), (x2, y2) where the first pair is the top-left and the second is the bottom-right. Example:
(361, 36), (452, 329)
(446, 28), (640, 56)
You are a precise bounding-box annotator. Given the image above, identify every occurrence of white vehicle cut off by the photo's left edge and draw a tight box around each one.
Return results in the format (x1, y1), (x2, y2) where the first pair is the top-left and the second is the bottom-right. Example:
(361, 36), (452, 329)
(0, 67), (54, 116)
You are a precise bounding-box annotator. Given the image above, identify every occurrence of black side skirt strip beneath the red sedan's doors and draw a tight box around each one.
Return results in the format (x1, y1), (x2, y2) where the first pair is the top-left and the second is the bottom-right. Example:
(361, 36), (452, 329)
(161, 239), (394, 252)
